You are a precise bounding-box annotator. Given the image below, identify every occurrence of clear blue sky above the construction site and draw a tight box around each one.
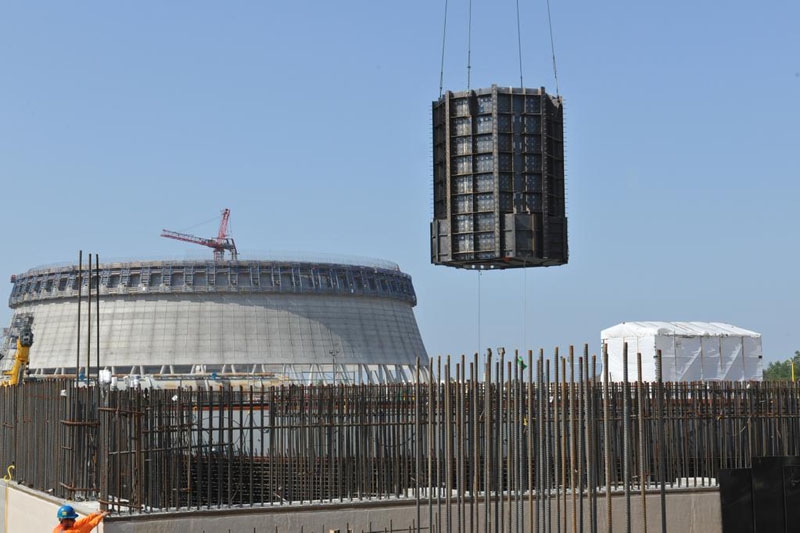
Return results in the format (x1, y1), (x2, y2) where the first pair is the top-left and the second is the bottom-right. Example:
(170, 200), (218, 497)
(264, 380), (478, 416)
(0, 0), (800, 362)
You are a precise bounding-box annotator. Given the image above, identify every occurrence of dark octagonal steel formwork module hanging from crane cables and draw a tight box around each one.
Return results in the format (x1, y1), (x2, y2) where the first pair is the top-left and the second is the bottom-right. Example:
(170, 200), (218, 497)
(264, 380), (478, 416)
(431, 85), (569, 268)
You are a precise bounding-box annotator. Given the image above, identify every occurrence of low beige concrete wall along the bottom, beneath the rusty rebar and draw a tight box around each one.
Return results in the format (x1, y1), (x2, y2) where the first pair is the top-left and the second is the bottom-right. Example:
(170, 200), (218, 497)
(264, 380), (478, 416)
(0, 481), (722, 533)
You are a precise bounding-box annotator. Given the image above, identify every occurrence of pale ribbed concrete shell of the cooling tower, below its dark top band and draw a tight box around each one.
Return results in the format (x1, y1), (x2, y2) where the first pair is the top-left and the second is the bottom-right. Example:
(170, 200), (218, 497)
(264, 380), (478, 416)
(3, 293), (426, 372)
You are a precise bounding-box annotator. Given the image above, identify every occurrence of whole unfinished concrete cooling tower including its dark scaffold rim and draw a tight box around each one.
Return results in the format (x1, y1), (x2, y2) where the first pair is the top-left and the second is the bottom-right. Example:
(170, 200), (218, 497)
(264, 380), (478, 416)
(0, 260), (428, 383)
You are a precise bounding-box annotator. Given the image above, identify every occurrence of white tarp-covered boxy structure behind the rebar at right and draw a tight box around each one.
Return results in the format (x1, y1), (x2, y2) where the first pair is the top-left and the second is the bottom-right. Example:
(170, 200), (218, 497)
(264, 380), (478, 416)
(600, 322), (763, 381)
